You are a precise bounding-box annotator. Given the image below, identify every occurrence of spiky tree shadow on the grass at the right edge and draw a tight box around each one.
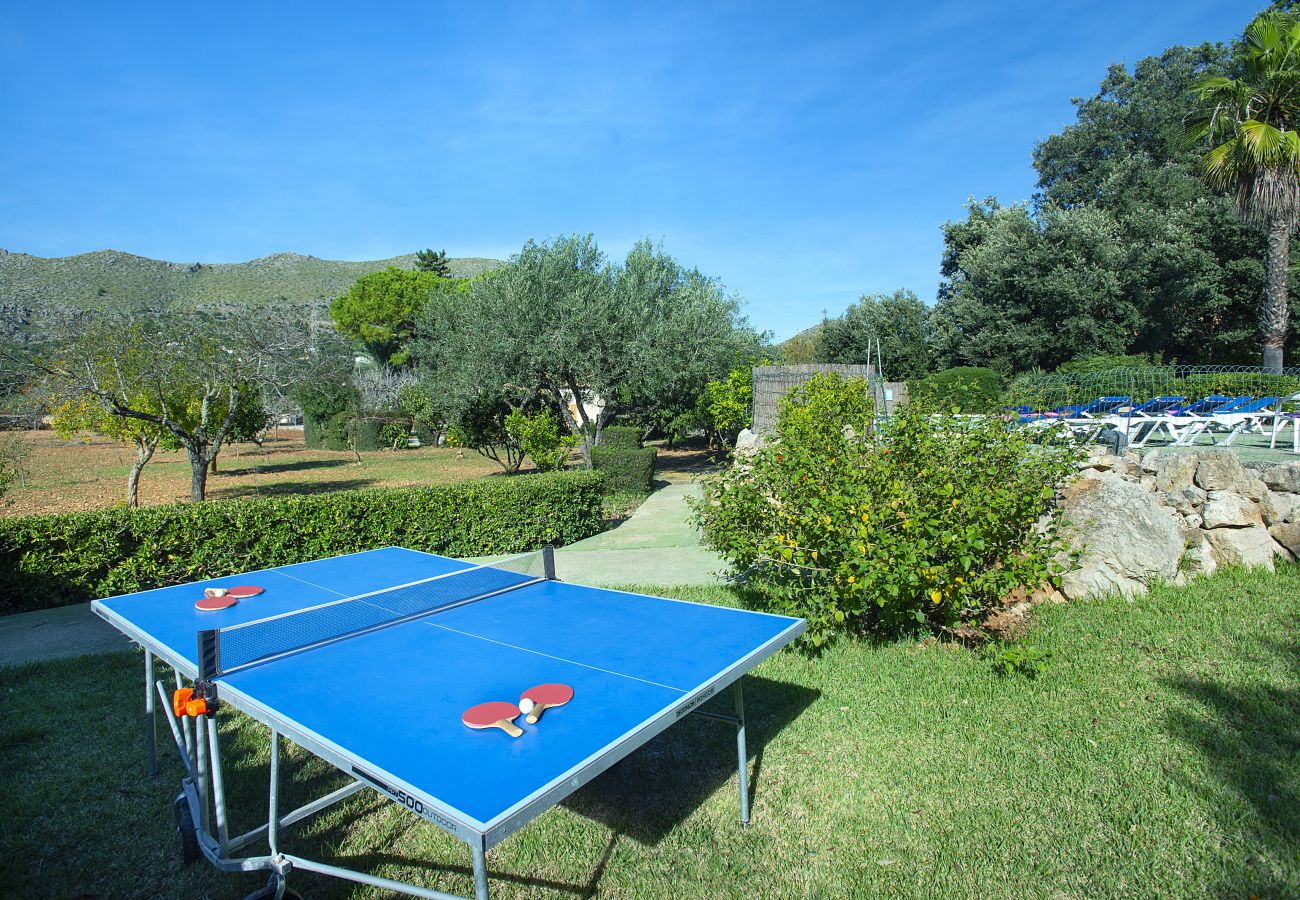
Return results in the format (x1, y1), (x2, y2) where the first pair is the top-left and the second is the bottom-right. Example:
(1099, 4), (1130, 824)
(1166, 639), (1300, 897)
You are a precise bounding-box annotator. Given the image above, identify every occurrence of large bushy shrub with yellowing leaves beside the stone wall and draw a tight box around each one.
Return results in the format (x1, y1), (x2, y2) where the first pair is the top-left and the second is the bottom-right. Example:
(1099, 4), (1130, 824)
(696, 376), (1075, 645)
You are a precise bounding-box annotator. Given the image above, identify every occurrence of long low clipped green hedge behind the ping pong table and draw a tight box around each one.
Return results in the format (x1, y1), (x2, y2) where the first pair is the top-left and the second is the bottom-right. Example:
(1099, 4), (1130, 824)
(0, 472), (603, 614)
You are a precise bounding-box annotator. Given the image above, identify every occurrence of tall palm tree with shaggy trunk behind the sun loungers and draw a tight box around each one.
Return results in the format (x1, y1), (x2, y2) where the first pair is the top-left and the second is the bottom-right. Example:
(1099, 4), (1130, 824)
(1188, 12), (1300, 372)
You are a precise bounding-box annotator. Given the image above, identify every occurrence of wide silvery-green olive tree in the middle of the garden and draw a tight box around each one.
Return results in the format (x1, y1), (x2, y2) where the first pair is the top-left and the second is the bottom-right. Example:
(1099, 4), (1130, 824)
(415, 235), (758, 464)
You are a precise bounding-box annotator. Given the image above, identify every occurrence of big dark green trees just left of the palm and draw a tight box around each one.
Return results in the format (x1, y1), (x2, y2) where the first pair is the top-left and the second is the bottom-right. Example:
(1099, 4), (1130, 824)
(931, 44), (1294, 373)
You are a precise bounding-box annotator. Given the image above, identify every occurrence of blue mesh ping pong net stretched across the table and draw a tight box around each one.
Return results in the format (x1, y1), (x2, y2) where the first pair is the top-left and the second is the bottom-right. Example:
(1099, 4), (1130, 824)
(199, 548), (555, 682)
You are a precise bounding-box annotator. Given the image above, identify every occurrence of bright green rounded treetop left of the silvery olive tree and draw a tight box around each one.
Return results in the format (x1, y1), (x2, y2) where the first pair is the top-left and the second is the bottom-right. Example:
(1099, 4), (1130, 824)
(329, 268), (465, 365)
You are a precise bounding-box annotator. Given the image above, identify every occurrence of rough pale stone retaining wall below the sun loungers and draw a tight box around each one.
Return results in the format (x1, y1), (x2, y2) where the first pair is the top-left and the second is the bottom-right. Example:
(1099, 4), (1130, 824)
(1061, 447), (1300, 600)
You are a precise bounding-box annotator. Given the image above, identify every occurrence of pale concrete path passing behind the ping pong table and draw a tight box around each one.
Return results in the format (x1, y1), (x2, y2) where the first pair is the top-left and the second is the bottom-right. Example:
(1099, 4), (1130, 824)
(0, 483), (723, 667)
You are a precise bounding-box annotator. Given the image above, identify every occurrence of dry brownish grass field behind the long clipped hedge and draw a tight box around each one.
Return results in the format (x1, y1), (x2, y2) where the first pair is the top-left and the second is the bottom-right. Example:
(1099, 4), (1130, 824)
(0, 428), (501, 515)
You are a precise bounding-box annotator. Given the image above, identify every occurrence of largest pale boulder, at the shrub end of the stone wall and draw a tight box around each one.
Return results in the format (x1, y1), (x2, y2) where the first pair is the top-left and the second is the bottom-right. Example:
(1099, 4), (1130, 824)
(1061, 479), (1184, 600)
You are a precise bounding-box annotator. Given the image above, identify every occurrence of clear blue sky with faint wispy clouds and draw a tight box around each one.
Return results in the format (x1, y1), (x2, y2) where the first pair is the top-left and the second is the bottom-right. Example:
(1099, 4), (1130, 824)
(0, 0), (1264, 338)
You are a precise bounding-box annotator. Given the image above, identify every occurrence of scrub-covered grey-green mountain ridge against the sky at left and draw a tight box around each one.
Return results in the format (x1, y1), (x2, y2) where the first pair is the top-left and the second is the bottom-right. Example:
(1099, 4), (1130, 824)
(0, 250), (501, 319)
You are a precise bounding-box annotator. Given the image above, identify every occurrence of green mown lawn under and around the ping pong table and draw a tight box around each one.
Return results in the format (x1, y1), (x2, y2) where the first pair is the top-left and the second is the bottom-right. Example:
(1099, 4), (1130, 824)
(0, 567), (1300, 899)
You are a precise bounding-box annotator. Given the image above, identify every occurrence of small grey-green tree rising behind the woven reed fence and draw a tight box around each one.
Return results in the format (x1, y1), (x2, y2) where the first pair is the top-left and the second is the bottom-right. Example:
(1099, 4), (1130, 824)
(820, 290), (933, 380)
